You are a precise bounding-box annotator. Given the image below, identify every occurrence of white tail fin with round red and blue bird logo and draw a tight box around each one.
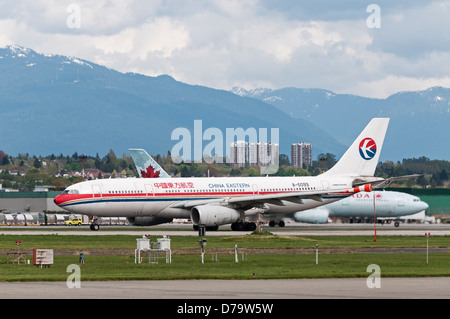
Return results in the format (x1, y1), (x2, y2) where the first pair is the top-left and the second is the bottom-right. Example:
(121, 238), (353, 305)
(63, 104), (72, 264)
(323, 118), (389, 176)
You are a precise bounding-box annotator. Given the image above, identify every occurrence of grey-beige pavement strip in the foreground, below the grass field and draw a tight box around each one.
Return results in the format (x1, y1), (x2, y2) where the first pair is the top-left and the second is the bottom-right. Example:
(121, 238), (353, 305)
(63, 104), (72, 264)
(0, 277), (450, 301)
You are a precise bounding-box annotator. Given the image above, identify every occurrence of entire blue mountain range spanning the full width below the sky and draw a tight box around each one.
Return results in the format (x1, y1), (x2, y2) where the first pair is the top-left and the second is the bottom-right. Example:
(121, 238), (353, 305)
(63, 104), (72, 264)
(0, 45), (450, 160)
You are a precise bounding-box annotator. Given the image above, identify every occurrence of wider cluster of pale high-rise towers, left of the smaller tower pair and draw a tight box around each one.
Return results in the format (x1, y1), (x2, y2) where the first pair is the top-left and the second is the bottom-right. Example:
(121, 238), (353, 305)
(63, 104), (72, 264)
(230, 141), (280, 167)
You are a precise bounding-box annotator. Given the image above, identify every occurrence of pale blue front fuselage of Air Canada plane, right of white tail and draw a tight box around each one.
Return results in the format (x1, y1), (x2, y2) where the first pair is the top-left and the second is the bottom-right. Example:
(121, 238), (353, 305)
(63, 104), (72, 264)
(294, 191), (428, 227)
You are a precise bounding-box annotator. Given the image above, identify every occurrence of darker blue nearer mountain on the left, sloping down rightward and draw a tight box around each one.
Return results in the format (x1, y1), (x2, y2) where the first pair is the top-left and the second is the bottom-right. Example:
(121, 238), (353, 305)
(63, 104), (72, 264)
(0, 46), (345, 159)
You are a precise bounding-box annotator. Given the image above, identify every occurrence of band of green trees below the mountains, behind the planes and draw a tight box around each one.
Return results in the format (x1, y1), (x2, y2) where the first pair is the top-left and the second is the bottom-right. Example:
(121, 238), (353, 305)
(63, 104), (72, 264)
(0, 150), (450, 191)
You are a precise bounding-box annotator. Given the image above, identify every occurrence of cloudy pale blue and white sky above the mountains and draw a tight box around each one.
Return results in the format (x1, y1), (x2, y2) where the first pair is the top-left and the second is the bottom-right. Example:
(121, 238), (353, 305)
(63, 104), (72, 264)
(0, 0), (450, 98)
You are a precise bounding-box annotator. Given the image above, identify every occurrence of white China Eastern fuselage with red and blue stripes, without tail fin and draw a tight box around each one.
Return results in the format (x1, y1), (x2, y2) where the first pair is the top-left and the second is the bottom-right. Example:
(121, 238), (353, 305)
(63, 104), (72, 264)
(55, 176), (353, 218)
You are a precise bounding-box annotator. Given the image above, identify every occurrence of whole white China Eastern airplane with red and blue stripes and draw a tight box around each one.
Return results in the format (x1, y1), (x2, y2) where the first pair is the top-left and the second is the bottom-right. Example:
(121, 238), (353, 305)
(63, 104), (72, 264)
(55, 118), (396, 235)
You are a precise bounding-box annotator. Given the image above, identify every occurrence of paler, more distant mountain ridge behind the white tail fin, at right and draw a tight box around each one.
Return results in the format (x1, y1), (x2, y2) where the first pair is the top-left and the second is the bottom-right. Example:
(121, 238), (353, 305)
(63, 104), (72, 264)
(232, 87), (450, 161)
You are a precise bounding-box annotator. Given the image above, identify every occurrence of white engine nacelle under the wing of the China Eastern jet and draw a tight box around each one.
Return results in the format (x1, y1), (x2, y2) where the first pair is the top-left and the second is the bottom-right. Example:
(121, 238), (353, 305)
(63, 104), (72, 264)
(191, 205), (241, 227)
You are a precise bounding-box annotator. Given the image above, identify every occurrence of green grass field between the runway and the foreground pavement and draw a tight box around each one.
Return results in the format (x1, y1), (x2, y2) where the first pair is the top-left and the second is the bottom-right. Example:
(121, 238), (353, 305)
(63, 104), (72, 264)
(0, 235), (450, 281)
